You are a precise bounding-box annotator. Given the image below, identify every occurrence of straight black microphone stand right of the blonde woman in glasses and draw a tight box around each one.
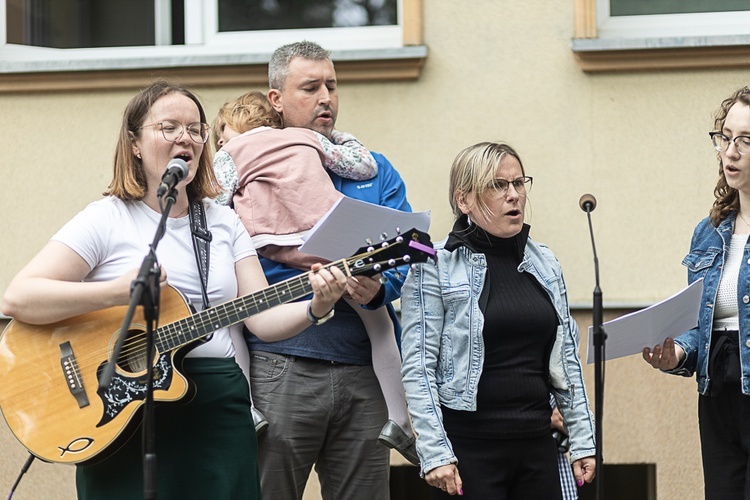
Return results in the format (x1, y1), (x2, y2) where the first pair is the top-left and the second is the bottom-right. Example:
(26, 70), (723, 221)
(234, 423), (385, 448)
(582, 202), (607, 500)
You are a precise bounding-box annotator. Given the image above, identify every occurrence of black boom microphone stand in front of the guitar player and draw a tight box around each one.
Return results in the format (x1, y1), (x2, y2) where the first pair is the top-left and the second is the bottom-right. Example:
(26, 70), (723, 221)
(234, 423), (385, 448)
(99, 188), (177, 500)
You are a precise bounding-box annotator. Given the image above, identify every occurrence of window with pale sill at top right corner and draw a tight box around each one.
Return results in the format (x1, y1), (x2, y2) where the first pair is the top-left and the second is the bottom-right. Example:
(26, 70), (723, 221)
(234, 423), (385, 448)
(572, 0), (750, 72)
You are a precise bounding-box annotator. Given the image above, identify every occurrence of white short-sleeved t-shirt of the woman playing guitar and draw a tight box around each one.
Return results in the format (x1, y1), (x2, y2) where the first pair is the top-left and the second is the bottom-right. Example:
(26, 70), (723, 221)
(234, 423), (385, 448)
(52, 197), (255, 358)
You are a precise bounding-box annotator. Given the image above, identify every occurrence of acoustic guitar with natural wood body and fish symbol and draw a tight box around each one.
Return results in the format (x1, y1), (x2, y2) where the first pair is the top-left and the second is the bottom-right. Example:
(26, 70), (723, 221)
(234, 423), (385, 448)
(0, 229), (435, 464)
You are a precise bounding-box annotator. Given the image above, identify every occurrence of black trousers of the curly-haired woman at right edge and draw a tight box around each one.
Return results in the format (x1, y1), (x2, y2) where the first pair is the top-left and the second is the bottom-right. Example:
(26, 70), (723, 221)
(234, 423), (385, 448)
(698, 332), (750, 500)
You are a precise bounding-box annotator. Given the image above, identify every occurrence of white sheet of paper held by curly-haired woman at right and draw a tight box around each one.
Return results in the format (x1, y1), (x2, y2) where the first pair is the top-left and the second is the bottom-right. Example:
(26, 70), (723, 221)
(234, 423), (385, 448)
(586, 279), (703, 364)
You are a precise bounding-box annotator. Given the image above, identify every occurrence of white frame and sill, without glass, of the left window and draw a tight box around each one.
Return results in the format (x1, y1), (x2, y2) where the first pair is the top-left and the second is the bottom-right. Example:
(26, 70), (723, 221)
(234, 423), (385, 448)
(0, 0), (427, 92)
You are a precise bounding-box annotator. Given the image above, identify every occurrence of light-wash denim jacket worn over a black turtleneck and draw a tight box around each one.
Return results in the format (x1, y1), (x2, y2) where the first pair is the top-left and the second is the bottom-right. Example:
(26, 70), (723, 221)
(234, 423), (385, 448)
(401, 229), (595, 474)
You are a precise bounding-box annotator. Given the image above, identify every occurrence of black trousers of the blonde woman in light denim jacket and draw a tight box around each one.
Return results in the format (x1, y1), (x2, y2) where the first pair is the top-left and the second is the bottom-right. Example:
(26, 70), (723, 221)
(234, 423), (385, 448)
(431, 434), (562, 500)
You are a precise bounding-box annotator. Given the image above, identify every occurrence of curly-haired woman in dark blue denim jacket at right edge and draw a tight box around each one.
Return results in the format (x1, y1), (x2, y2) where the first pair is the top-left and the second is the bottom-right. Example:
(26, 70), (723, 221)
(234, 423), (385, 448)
(643, 87), (750, 499)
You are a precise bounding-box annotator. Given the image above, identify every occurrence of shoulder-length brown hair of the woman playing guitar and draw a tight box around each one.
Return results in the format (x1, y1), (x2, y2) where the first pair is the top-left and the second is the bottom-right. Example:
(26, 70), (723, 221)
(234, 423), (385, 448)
(104, 80), (221, 200)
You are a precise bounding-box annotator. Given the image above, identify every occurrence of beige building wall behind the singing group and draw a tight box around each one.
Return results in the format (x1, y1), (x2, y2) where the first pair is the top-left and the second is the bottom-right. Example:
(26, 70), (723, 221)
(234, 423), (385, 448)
(0, 0), (750, 500)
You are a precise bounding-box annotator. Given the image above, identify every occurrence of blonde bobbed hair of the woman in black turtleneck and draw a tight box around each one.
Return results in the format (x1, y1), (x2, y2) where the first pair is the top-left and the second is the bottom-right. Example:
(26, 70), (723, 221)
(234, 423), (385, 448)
(448, 142), (526, 219)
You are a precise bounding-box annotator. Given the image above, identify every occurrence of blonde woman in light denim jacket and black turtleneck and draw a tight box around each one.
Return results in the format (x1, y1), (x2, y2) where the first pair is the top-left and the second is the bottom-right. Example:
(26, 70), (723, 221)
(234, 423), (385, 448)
(401, 143), (595, 499)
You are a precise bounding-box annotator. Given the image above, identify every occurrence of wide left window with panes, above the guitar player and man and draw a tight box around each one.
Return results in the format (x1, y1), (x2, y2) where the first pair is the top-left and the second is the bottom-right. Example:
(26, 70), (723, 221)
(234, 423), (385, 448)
(0, 0), (426, 91)
